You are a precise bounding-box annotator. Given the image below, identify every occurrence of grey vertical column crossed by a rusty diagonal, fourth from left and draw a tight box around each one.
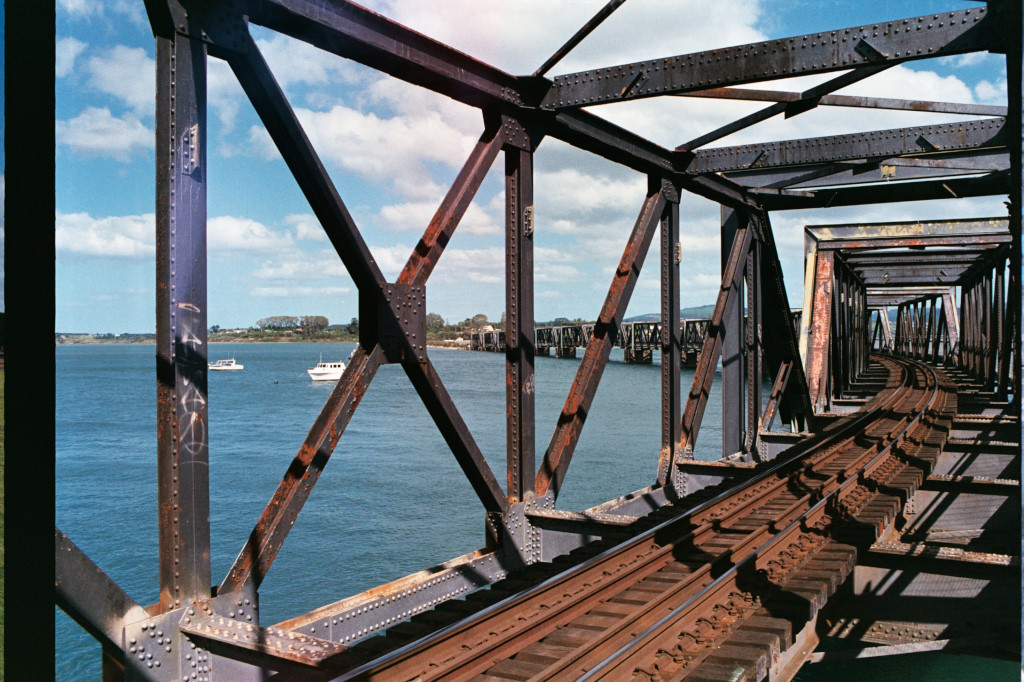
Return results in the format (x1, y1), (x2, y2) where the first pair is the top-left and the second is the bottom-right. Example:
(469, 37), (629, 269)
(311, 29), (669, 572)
(712, 205), (750, 450)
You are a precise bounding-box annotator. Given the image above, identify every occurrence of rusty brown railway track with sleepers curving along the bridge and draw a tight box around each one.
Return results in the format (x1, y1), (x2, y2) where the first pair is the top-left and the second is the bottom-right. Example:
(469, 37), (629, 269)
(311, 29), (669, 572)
(188, 356), (956, 681)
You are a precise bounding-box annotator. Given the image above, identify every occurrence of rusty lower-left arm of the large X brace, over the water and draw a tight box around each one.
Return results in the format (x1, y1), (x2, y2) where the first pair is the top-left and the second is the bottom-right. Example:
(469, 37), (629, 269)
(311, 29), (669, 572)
(218, 346), (384, 594)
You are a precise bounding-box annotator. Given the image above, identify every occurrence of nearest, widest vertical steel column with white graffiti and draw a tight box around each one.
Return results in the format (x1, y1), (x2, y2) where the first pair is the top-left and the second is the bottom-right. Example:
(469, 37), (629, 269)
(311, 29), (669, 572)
(156, 29), (210, 610)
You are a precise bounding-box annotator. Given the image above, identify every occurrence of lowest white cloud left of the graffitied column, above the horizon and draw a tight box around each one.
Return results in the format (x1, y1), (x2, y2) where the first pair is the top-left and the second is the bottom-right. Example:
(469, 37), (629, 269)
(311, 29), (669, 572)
(54, 211), (156, 259)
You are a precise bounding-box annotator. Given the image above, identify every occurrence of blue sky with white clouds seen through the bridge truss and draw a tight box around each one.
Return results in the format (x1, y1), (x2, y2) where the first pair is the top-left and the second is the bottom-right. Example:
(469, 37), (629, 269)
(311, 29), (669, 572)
(54, 0), (1006, 332)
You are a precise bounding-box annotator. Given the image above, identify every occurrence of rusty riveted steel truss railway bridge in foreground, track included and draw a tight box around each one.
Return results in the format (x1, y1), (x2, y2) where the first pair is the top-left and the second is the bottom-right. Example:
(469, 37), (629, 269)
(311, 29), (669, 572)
(44, 0), (1022, 681)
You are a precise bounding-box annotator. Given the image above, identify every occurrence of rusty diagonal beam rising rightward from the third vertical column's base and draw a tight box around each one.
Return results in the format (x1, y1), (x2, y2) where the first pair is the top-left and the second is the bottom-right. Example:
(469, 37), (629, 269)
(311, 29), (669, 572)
(679, 224), (754, 459)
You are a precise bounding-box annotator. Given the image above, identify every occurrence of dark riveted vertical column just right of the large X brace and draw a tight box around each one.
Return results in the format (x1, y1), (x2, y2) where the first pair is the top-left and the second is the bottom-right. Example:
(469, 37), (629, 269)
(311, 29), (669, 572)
(505, 127), (537, 503)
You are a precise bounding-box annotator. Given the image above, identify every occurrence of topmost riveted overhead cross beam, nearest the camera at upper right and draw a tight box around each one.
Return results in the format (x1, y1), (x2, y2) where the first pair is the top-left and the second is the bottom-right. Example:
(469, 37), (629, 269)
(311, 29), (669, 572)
(541, 7), (1001, 109)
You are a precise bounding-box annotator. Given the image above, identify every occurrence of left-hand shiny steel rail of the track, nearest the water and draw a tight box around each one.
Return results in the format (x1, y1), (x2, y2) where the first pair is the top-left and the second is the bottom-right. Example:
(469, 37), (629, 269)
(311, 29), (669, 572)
(327, 352), (929, 679)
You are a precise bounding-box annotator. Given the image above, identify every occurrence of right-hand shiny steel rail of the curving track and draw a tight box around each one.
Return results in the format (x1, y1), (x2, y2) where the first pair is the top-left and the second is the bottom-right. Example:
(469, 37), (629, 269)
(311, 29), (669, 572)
(579, 352), (940, 680)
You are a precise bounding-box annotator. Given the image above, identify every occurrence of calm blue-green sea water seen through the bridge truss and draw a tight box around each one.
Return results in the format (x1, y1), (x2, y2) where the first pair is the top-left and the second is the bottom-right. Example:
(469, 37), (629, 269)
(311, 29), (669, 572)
(55, 343), (721, 680)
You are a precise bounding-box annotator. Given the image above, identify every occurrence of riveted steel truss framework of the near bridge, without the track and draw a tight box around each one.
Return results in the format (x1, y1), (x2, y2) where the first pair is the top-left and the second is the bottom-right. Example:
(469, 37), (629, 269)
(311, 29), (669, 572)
(49, 0), (1021, 680)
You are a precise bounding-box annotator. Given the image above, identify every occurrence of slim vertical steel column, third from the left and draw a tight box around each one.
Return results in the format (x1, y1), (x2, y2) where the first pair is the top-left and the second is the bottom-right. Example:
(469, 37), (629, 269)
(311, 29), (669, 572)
(648, 177), (683, 485)
